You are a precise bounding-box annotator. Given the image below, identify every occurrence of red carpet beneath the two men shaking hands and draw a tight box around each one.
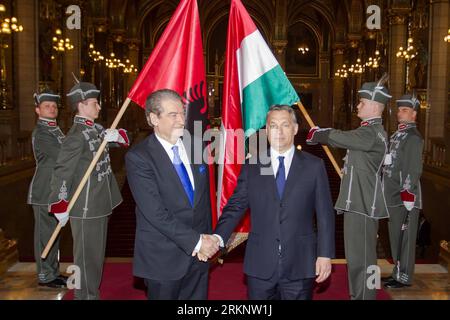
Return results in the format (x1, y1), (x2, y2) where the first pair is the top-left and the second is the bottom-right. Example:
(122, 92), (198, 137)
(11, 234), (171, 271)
(64, 262), (390, 300)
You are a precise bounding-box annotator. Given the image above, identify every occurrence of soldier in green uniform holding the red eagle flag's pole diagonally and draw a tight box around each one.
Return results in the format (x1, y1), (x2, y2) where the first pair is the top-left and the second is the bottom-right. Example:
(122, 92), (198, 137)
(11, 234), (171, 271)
(49, 82), (129, 300)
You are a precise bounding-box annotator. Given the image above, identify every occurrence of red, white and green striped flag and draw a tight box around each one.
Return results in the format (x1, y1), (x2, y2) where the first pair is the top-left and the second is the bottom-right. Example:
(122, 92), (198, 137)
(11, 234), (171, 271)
(218, 0), (299, 232)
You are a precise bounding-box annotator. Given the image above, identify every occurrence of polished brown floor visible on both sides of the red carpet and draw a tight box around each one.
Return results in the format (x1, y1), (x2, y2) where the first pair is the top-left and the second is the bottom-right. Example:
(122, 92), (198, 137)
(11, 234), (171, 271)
(0, 258), (450, 300)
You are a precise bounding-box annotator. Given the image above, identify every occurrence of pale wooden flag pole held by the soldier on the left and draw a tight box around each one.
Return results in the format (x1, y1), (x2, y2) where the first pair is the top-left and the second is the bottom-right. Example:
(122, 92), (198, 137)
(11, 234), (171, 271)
(41, 98), (131, 259)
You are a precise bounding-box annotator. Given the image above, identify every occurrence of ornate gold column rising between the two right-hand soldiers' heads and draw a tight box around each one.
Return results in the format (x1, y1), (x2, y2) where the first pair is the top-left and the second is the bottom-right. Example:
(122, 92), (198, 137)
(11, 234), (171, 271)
(385, 8), (409, 134)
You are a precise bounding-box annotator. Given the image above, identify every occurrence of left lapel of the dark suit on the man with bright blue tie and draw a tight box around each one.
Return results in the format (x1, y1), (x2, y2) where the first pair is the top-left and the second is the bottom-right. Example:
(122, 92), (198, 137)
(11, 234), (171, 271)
(148, 134), (191, 206)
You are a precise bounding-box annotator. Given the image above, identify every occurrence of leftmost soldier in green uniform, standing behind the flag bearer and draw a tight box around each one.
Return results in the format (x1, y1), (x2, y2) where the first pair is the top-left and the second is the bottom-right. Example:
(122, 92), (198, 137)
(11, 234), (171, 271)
(27, 89), (67, 288)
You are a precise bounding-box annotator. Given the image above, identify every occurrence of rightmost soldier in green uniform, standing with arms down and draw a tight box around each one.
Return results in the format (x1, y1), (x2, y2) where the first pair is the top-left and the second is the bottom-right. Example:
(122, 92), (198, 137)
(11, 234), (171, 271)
(383, 94), (423, 288)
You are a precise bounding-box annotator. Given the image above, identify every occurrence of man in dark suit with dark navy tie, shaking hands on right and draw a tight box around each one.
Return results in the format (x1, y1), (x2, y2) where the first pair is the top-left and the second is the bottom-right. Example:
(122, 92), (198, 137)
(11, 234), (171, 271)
(214, 105), (335, 300)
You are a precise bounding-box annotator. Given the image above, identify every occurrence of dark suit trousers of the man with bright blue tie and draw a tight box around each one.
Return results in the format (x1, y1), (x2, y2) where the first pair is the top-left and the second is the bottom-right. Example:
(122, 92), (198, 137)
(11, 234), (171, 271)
(144, 258), (208, 300)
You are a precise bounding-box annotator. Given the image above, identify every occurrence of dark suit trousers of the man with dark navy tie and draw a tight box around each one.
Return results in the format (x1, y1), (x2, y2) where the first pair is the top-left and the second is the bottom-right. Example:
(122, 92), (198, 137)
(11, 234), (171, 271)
(247, 255), (314, 300)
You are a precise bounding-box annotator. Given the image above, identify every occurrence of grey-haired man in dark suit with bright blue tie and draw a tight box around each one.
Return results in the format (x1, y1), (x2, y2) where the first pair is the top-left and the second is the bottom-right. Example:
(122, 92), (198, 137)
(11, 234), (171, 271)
(126, 89), (219, 299)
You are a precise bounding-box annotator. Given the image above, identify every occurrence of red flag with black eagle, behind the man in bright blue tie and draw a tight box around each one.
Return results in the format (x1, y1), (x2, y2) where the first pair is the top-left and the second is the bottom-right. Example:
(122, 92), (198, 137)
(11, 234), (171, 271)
(128, 0), (217, 224)
